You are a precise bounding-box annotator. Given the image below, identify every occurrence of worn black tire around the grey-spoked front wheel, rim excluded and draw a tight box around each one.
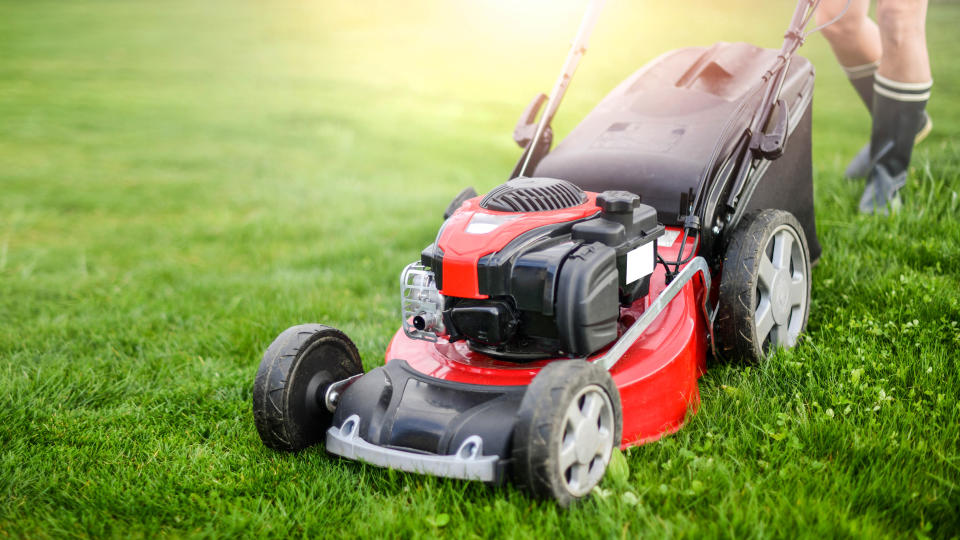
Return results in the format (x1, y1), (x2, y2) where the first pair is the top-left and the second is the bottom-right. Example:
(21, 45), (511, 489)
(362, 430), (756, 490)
(511, 360), (623, 507)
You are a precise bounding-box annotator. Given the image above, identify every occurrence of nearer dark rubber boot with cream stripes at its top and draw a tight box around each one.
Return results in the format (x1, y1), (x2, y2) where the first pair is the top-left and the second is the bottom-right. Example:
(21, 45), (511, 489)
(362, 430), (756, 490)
(860, 74), (933, 215)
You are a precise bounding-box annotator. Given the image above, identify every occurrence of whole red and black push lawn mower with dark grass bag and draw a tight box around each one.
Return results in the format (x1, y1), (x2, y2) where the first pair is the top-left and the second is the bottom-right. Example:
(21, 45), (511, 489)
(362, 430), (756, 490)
(254, 0), (822, 500)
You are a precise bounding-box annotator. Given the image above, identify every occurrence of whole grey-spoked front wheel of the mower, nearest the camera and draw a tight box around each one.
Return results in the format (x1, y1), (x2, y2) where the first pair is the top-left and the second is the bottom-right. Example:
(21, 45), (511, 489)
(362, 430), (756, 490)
(513, 360), (623, 506)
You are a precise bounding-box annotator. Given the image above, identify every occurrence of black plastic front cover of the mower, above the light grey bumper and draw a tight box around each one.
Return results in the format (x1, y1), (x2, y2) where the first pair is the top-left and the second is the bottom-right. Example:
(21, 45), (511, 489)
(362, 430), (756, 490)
(333, 360), (527, 478)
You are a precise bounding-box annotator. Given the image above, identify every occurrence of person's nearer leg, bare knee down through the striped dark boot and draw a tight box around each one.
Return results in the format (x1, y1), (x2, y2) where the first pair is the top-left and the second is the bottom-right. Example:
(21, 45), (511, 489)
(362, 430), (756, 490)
(860, 0), (933, 213)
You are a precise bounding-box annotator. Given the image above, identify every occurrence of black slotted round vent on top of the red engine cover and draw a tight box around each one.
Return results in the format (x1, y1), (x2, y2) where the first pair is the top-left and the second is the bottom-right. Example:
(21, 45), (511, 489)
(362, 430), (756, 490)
(480, 178), (587, 212)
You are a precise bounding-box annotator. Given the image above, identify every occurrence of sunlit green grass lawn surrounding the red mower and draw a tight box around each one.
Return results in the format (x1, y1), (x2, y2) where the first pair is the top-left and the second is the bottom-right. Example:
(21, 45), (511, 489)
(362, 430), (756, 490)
(0, 0), (960, 538)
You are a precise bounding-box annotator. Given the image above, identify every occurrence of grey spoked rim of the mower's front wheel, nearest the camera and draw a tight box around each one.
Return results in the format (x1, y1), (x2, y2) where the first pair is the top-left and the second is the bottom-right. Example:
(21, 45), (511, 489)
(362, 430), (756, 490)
(557, 385), (615, 497)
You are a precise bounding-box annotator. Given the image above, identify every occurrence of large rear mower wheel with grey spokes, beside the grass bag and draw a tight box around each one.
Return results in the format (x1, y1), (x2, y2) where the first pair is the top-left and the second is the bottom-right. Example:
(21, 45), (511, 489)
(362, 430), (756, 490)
(714, 210), (810, 363)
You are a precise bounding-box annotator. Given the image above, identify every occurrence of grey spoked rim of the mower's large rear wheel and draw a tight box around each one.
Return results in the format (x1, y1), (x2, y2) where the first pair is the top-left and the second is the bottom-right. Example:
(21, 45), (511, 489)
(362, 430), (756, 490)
(754, 225), (809, 353)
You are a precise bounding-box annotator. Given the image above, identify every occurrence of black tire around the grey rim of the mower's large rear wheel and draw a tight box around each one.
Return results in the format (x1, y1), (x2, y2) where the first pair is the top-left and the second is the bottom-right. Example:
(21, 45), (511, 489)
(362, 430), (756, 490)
(713, 209), (812, 364)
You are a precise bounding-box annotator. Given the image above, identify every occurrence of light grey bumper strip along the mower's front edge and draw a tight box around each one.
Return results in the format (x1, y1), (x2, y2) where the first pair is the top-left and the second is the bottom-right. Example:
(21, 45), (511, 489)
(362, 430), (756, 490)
(327, 415), (500, 482)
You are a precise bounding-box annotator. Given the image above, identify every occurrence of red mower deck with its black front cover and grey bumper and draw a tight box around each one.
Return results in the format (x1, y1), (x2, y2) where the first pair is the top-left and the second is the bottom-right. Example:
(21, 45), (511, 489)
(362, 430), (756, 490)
(326, 233), (712, 483)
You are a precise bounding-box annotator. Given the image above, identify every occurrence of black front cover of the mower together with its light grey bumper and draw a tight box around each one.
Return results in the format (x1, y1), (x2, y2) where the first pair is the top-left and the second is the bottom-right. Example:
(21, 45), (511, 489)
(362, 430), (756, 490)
(326, 359), (526, 483)
